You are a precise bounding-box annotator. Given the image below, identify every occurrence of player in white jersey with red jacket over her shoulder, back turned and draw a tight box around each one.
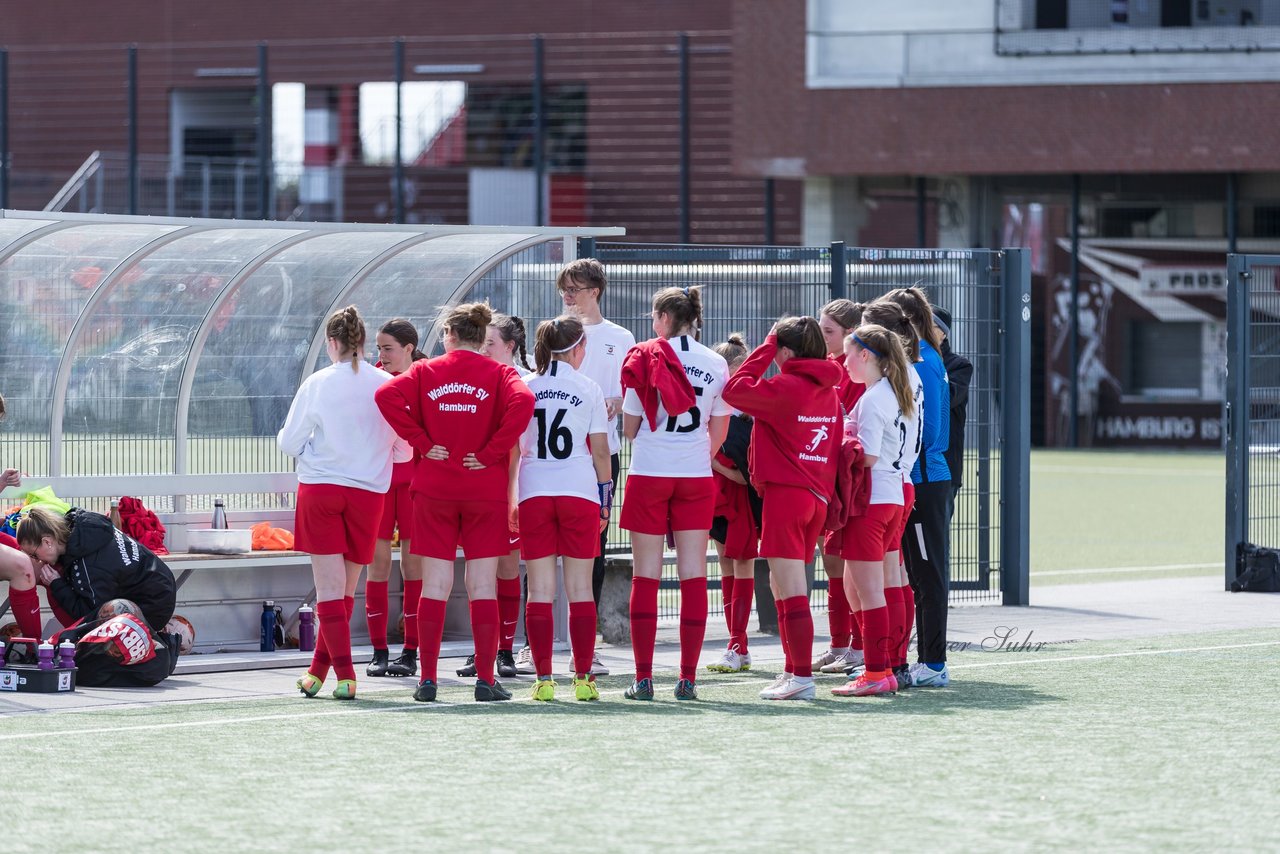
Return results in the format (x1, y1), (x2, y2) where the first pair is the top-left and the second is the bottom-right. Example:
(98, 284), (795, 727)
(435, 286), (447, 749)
(621, 287), (732, 700)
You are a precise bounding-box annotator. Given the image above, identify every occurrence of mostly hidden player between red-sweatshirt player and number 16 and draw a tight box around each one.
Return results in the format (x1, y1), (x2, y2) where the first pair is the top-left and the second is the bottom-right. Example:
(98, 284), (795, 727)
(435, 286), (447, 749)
(457, 312), (532, 679)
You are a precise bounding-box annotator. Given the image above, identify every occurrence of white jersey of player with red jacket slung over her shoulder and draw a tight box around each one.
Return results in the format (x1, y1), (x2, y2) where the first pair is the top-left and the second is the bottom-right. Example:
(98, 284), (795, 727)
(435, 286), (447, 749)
(622, 335), (733, 478)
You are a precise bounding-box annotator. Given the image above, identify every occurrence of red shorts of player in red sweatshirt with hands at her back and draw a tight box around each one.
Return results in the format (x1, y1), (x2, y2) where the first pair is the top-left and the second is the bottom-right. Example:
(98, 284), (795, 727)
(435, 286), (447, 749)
(408, 493), (513, 561)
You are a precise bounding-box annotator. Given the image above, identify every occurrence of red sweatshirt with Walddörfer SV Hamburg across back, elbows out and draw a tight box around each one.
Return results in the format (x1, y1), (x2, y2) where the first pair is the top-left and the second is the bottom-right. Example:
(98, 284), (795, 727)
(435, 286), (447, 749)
(374, 350), (534, 503)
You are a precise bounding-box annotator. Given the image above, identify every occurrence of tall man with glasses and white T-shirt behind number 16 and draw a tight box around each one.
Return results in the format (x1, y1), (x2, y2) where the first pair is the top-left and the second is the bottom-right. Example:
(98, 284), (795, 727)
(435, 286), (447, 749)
(560, 257), (636, 676)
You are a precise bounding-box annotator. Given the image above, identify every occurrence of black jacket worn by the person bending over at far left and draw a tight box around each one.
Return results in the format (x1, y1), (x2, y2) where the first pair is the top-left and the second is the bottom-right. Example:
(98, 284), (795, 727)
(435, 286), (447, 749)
(49, 507), (178, 631)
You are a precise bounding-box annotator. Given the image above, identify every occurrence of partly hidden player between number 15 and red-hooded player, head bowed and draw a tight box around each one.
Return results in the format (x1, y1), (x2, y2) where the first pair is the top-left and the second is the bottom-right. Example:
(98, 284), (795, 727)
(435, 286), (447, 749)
(707, 333), (763, 673)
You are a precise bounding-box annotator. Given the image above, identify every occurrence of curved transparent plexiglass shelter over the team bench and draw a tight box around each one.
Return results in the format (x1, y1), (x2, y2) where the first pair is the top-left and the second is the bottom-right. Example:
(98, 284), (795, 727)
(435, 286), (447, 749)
(0, 211), (621, 476)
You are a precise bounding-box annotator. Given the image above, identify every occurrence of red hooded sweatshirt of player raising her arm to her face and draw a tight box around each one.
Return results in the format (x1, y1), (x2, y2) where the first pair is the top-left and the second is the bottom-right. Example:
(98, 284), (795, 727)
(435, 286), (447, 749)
(724, 334), (844, 501)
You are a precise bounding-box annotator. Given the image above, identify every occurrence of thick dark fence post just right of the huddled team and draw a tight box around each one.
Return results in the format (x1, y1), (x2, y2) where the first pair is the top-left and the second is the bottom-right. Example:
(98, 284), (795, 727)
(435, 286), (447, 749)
(1000, 250), (1032, 606)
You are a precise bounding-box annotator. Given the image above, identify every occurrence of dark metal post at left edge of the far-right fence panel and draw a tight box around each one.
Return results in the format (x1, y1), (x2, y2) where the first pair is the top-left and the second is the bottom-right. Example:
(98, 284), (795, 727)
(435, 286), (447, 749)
(1224, 254), (1251, 589)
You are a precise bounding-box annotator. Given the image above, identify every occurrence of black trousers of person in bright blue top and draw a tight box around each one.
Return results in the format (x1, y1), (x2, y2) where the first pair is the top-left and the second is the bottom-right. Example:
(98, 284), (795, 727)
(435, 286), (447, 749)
(902, 480), (954, 665)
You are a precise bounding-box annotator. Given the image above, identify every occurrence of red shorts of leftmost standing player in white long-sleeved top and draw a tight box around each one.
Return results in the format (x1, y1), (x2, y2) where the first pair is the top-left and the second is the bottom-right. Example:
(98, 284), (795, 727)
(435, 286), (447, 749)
(293, 484), (384, 563)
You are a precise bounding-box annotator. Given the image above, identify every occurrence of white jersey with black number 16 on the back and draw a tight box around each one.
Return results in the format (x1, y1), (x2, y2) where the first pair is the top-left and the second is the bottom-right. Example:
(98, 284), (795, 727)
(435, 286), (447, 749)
(520, 361), (609, 501)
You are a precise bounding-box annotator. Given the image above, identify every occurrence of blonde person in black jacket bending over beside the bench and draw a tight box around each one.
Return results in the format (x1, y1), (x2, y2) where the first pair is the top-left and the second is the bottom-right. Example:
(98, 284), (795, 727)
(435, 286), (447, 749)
(17, 506), (177, 632)
